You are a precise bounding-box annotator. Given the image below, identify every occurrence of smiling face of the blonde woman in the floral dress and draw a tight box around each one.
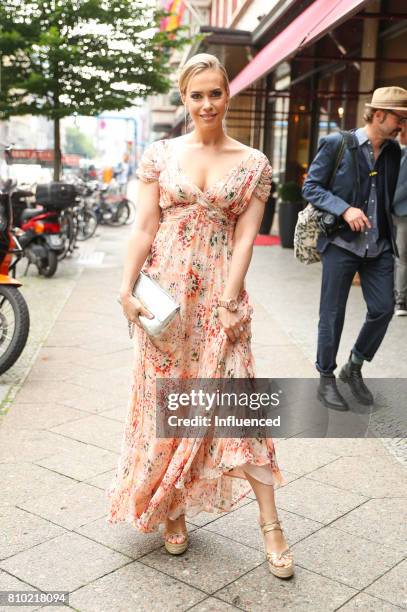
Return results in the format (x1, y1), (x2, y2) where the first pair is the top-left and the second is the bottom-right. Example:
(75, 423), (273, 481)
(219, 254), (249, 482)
(183, 68), (229, 129)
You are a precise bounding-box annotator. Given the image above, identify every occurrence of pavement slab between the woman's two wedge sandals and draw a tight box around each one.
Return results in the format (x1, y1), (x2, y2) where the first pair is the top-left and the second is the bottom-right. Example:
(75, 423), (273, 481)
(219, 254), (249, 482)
(143, 529), (264, 594)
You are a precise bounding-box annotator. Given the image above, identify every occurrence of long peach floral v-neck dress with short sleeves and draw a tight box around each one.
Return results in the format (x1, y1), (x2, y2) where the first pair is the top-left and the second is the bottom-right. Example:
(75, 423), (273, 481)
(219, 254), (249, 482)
(107, 140), (284, 532)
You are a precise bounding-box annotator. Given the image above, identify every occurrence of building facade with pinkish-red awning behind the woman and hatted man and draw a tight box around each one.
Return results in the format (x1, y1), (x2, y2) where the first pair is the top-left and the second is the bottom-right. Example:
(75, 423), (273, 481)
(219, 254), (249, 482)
(160, 0), (407, 184)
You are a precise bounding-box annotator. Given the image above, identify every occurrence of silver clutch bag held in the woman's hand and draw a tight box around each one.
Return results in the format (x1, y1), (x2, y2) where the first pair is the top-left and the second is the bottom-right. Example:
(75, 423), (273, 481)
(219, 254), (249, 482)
(119, 272), (180, 338)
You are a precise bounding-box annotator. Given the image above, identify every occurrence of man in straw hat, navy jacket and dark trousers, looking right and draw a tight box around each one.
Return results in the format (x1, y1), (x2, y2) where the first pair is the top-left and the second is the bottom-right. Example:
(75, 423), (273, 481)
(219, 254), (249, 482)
(303, 87), (407, 410)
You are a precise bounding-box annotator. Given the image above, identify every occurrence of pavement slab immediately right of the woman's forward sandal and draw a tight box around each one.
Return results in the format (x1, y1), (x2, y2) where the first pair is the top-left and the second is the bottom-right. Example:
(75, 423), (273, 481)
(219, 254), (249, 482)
(293, 527), (403, 590)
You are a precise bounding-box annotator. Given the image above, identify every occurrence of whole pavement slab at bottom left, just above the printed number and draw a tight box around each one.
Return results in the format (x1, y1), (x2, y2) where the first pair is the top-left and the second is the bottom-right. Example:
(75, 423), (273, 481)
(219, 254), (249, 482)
(0, 533), (130, 591)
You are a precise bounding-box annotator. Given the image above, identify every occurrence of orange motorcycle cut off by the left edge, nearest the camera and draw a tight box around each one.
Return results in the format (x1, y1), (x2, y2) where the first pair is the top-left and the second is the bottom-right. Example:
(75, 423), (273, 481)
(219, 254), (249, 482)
(0, 181), (30, 374)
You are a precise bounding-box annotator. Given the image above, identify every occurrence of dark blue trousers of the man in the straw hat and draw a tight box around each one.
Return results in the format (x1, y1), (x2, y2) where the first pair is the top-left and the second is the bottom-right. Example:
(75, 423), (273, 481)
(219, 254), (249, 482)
(315, 244), (394, 375)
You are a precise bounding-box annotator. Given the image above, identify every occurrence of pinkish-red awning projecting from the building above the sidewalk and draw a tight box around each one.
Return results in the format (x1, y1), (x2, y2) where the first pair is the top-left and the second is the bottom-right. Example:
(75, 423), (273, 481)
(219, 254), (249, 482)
(230, 0), (367, 96)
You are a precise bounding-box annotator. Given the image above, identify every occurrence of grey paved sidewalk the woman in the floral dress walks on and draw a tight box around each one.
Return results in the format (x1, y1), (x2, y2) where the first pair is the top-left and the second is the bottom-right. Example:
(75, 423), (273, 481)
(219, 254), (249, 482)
(0, 228), (407, 612)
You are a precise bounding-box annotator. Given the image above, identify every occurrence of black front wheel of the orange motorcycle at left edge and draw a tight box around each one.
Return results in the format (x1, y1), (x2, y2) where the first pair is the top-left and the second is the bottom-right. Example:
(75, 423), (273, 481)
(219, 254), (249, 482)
(0, 285), (30, 374)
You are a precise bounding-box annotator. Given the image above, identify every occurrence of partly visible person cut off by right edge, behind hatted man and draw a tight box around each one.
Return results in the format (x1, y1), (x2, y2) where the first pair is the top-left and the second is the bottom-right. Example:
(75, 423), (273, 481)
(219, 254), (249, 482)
(393, 124), (407, 316)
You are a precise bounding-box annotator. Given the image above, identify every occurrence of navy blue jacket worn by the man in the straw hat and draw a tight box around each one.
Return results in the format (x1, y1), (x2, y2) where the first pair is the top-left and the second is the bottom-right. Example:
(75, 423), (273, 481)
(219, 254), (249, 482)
(302, 132), (400, 253)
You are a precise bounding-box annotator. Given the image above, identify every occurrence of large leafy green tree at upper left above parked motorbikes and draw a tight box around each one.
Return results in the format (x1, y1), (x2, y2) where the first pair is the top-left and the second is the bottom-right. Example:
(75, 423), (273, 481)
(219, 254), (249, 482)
(0, 0), (190, 180)
